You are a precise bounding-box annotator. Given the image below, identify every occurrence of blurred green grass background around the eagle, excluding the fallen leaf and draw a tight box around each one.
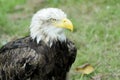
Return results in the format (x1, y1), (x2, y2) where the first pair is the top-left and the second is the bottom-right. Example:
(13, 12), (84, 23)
(0, 0), (120, 80)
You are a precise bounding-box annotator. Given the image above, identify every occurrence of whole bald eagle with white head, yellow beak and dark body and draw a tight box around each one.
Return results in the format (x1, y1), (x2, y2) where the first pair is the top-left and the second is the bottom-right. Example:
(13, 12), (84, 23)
(0, 8), (77, 80)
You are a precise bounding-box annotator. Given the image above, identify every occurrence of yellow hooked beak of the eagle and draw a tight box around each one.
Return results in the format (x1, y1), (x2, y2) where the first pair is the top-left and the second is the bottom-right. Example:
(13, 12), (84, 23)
(55, 18), (73, 31)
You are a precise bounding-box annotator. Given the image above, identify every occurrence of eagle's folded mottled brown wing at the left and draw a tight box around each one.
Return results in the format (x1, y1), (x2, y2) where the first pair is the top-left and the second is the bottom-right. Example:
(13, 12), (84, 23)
(0, 38), (45, 80)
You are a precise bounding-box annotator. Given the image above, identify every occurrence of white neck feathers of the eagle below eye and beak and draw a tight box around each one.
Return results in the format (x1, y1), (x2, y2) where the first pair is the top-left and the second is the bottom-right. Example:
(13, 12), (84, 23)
(30, 26), (66, 46)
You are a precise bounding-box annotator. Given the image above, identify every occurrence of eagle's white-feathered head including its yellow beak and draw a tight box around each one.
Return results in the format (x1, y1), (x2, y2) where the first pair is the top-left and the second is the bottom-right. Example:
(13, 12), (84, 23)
(30, 8), (73, 46)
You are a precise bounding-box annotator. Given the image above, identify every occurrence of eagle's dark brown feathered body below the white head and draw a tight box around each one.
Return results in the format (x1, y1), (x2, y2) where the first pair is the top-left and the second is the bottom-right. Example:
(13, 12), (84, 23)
(0, 37), (76, 80)
